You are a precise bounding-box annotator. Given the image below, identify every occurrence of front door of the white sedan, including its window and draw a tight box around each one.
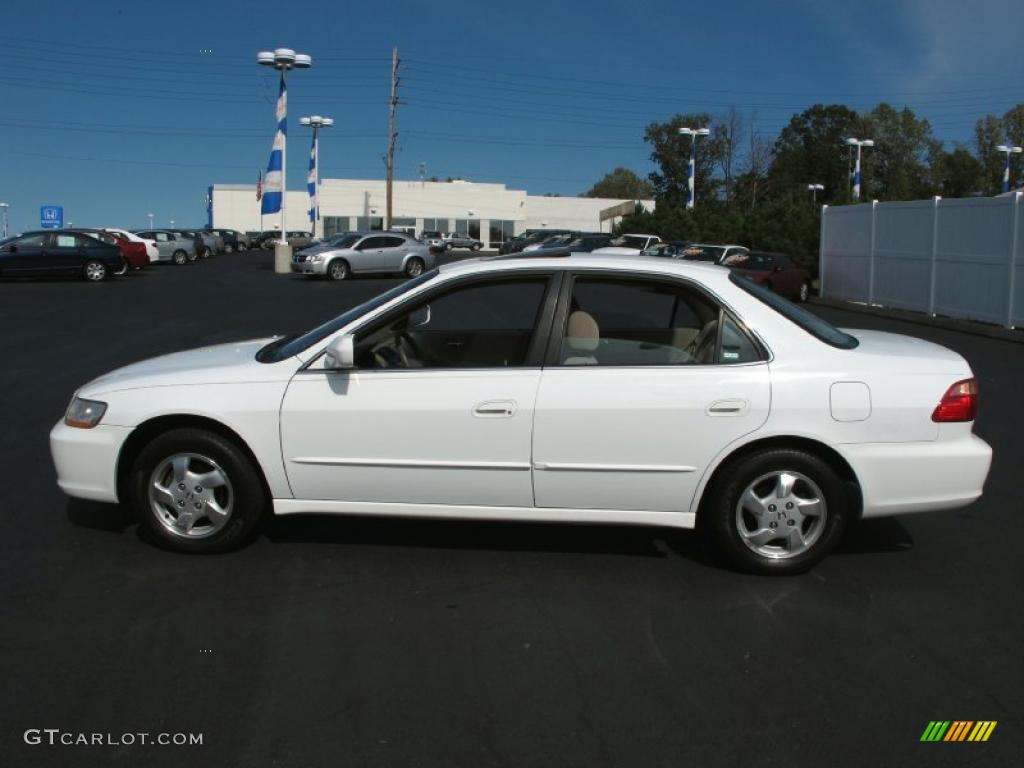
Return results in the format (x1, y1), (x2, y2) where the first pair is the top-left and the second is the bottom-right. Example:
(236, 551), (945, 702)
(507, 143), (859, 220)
(281, 273), (554, 507)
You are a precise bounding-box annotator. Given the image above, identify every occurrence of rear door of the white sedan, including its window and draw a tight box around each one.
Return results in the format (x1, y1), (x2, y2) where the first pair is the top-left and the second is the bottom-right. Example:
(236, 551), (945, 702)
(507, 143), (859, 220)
(534, 273), (771, 512)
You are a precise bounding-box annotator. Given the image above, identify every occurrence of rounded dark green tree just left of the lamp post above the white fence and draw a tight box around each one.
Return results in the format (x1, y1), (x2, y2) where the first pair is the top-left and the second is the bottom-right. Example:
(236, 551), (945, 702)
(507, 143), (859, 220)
(766, 104), (864, 203)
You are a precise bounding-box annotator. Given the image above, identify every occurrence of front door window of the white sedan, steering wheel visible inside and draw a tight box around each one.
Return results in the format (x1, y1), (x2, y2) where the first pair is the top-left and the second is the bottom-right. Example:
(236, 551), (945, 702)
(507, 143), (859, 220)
(355, 278), (548, 369)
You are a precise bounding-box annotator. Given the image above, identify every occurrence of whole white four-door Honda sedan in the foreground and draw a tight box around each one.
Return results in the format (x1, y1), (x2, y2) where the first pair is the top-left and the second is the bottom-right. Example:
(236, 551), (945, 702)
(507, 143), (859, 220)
(50, 255), (991, 573)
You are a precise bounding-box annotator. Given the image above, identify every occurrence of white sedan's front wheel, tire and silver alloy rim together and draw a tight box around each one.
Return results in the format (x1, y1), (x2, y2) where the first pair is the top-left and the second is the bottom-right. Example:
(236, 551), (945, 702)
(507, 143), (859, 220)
(128, 427), (268, 553)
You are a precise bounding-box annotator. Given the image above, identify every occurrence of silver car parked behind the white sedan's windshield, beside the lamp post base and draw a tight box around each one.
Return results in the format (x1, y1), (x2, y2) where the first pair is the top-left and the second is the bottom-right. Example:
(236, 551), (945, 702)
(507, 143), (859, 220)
(292, 231), (437, 280)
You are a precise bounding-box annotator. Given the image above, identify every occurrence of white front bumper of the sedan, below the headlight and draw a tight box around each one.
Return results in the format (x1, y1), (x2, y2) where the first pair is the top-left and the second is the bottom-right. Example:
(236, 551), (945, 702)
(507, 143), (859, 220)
(50, 420), (131, 502)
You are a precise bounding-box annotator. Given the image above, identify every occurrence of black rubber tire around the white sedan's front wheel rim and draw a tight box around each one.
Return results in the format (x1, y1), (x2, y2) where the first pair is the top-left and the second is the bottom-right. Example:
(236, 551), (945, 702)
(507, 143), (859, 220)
(127, 427), (270, 554)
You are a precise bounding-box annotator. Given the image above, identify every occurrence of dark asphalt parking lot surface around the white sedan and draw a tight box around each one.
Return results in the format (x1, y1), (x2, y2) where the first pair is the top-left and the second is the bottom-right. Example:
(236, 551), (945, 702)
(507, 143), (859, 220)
(0, 253), (1024, 768)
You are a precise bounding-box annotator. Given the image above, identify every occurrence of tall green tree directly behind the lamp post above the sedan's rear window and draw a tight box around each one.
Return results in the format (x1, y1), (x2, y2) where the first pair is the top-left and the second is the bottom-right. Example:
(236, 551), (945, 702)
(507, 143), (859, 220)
(644, 113), (718, 205)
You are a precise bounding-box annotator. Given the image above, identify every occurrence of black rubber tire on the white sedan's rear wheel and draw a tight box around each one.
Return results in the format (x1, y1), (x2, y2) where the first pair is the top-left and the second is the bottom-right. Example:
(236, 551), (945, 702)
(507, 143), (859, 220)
(698, 449), (850, 575)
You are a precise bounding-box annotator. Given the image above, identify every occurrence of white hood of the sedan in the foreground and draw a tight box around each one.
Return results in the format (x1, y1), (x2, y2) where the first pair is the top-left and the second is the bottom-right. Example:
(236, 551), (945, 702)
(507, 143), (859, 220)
(79, 337), (294, 397)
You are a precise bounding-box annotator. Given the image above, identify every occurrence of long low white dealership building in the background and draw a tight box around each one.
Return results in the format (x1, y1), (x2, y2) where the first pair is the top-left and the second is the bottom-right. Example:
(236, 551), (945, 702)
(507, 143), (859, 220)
(209, 179), (654, 248)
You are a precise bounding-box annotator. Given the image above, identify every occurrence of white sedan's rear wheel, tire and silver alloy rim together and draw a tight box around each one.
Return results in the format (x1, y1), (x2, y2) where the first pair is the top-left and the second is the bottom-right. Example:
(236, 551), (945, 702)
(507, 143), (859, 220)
(699, 449), (848, 575)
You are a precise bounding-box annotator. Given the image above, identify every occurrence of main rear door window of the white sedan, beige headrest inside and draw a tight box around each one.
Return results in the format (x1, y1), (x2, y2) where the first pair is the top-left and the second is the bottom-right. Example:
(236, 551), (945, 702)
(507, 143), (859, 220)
(559, 278), (720, 366)
